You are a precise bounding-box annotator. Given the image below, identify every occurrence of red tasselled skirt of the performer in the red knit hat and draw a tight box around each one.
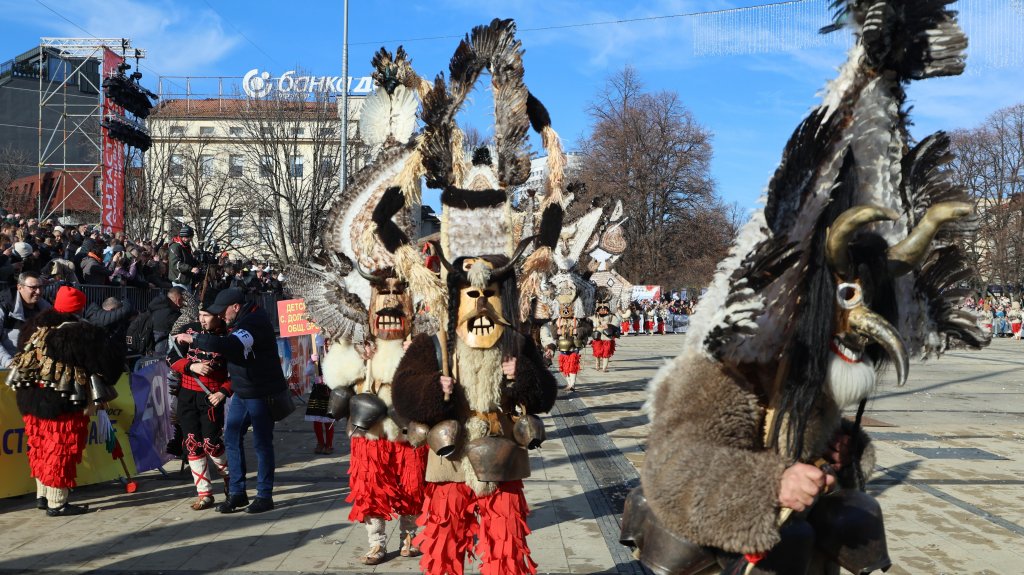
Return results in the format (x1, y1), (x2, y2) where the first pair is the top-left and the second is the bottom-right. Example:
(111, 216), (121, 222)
(22, 411), (89, 489)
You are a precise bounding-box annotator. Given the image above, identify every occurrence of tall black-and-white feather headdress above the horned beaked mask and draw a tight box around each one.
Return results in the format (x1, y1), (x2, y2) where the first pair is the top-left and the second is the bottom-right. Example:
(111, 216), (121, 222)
(687, 0), (980, 376)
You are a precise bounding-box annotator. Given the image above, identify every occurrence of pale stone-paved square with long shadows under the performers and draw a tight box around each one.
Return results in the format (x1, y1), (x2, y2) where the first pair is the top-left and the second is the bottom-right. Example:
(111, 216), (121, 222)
(0, 336), (1024, 575)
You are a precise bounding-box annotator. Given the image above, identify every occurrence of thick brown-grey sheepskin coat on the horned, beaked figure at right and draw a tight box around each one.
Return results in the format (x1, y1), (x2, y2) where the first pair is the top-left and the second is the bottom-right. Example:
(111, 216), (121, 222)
(641, 352), (873, 554)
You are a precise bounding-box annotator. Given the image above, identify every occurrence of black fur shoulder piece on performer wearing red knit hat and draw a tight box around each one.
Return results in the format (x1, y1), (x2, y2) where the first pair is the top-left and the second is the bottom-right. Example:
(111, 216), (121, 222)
(46, 315), (124, 385)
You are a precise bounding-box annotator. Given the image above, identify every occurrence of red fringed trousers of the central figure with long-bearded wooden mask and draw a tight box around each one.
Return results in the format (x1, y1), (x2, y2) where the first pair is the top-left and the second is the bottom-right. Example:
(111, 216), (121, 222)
(413, 481), (537, 575)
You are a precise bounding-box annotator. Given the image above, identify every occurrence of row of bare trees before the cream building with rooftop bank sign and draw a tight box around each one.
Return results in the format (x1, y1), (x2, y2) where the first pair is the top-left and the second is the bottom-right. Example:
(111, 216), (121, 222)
(126, 89), (364, 263)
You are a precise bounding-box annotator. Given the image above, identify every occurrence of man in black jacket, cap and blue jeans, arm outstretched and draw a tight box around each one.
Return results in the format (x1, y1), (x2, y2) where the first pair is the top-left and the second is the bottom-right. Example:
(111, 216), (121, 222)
(175, 288), (288, 513)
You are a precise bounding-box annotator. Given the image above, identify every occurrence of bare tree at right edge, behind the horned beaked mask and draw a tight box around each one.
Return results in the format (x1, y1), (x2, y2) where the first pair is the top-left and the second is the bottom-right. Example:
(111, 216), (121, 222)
(950, 103), (1024, 288)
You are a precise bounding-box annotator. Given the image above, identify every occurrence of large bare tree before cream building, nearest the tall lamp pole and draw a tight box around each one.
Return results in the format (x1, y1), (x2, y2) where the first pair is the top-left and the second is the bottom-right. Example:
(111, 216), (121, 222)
(238, 88), (362, 263)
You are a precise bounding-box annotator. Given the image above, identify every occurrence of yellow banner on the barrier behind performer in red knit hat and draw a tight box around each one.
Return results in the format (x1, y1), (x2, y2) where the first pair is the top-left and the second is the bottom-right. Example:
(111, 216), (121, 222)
(0, 369), (135, 497)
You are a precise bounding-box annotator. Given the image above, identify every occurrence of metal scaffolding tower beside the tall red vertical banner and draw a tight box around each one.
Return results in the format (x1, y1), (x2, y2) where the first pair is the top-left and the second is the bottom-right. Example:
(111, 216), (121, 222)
(37, 38), (145, 220)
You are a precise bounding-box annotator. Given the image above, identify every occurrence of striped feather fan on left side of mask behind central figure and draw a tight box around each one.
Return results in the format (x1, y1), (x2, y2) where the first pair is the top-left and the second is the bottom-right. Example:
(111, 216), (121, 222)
(285, 264), (369, 342)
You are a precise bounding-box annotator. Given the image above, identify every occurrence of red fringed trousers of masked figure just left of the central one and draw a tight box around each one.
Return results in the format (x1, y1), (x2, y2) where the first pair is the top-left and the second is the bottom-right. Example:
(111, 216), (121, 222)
(345, 437), (427, 523)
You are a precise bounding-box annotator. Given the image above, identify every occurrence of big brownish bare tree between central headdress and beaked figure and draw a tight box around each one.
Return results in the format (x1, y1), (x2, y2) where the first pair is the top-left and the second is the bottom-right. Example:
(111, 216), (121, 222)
(574, 67), (735, 286)
